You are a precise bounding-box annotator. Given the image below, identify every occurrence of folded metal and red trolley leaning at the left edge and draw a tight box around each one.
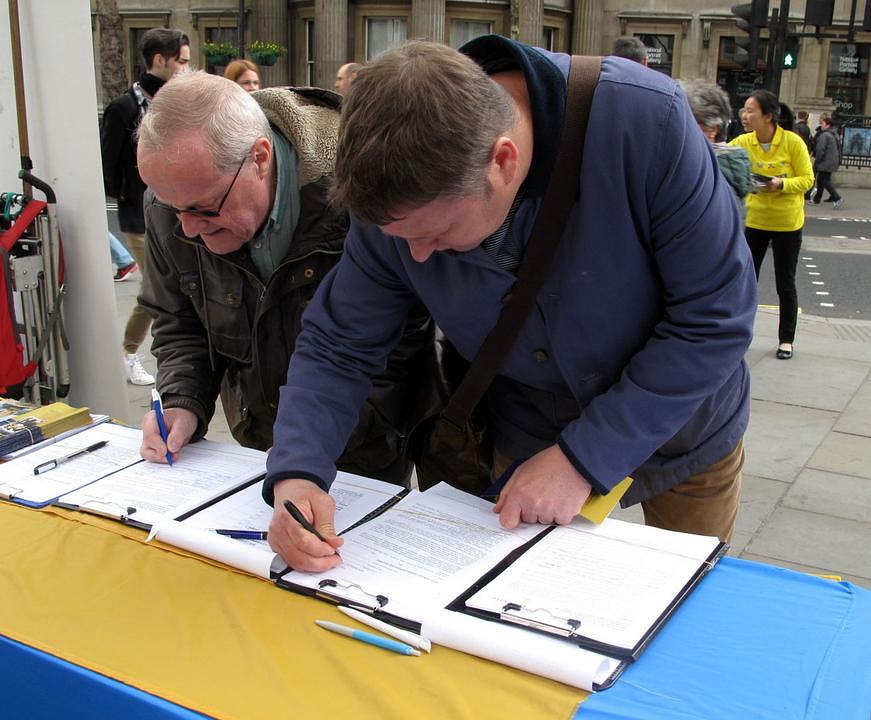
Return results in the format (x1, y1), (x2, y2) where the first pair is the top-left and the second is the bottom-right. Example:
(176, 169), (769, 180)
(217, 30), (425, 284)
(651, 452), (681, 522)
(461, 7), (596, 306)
(0, 170), (70, 404)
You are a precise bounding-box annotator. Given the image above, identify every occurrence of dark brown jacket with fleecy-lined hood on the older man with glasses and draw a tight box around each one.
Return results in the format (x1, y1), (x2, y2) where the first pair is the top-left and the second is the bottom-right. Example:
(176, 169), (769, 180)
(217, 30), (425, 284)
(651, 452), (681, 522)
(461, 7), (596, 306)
(139, 88), (431, 482)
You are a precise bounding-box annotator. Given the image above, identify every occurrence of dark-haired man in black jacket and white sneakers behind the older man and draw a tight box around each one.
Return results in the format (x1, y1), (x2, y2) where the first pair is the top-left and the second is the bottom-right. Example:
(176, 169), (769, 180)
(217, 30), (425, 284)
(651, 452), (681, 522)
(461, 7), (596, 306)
(100, 28), (191, 385)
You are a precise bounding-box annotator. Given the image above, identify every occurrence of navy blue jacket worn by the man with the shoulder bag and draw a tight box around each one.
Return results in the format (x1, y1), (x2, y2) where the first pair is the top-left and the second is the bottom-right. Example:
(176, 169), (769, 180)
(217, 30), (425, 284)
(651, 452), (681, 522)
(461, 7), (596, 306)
(267, 36), (756, 503)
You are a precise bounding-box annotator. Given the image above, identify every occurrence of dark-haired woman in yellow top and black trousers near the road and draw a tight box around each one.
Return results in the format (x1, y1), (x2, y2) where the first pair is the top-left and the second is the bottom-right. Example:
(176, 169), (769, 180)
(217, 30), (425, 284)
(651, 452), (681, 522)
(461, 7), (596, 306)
(731, 90), (814, 360)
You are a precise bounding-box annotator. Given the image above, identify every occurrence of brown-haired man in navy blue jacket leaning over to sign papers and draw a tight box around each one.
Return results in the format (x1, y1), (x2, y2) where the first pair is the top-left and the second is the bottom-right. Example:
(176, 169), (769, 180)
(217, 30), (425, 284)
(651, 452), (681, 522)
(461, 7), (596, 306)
(264, 36), (756, 570)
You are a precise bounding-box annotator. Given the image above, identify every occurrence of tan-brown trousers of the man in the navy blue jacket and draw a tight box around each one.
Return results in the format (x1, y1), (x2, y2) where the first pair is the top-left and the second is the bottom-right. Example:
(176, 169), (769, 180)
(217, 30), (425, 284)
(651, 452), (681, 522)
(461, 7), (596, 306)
(492, 440), (744, 542)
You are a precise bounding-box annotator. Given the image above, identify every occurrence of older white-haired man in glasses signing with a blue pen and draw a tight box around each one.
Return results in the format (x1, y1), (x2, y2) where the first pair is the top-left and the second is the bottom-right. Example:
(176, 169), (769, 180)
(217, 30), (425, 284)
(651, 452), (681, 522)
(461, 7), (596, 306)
(138, 72), (430, 490)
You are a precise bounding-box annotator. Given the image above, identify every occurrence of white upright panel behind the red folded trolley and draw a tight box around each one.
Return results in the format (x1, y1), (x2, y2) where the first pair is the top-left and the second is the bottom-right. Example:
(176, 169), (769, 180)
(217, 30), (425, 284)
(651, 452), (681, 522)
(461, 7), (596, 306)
(0, 0), (129, 420)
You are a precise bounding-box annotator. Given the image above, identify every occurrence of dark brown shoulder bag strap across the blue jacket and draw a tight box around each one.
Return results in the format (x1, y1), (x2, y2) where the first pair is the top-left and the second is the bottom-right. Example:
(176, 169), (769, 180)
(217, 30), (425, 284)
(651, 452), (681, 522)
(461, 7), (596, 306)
(442, 55), (602, 427)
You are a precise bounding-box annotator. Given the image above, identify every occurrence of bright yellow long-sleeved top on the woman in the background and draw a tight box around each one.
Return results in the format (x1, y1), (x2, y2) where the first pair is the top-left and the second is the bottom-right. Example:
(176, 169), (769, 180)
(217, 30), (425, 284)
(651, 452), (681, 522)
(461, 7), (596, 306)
(729, 127), (814, 232)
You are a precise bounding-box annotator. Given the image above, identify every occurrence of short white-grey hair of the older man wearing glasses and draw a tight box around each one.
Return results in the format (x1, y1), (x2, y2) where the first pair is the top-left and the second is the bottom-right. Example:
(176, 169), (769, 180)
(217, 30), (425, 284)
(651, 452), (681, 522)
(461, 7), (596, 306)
(137, 70), (272, 173)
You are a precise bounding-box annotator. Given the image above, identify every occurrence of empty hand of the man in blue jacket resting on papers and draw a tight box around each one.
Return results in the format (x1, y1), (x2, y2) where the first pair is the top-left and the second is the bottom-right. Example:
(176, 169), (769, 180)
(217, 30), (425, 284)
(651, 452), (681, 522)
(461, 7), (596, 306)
(493, 445), (592, 529)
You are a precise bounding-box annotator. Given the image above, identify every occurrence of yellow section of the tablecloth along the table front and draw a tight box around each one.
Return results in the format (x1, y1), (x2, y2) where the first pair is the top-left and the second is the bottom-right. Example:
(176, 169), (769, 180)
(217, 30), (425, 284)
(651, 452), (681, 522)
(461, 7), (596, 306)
(0, 503), (586, 720)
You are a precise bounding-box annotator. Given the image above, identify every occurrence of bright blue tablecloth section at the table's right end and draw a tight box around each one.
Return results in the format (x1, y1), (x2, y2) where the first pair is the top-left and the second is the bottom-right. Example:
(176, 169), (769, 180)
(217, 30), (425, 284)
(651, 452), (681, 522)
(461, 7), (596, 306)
(575, 558), (871, 720)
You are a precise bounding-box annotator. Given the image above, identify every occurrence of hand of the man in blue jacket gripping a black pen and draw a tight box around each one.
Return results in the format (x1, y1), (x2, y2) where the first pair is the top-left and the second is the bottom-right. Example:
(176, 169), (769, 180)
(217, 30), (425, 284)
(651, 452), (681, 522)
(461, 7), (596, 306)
(268, 480), (344, 572)
